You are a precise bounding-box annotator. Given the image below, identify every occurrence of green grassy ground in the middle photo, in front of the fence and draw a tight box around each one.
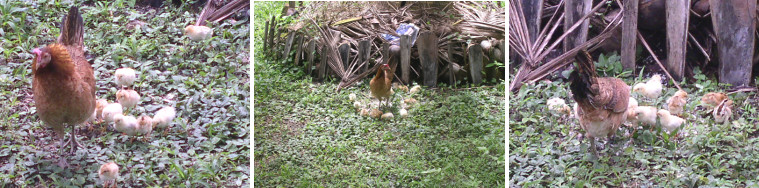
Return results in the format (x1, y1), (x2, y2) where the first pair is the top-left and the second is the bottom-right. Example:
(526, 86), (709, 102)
(253, 2), (506, 187)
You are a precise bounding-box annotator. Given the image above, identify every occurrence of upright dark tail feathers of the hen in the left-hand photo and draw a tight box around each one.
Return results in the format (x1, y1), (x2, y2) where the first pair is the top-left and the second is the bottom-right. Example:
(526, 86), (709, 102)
(58, 6), (84, 46)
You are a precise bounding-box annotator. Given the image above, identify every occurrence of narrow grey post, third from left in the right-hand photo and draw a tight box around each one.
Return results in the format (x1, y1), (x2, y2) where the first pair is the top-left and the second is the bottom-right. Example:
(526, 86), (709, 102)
(621, 0), (638, 73)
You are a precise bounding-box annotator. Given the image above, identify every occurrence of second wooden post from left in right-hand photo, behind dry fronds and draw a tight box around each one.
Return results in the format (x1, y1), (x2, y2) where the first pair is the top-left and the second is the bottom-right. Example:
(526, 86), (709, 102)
(564, 0), (593, 53)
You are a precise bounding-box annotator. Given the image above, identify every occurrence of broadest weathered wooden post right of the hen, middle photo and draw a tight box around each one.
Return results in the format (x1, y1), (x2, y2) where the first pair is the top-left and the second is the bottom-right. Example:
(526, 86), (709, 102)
(417, 31), (438, 87)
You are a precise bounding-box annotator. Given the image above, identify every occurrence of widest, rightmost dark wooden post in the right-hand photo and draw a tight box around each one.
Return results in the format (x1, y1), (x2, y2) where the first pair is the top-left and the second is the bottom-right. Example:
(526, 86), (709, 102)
(709, 0), (756, 86)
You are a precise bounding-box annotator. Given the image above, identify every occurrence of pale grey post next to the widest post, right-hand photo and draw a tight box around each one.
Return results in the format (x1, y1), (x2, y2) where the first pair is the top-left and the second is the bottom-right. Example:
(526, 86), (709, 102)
(664, 0), (692, 81)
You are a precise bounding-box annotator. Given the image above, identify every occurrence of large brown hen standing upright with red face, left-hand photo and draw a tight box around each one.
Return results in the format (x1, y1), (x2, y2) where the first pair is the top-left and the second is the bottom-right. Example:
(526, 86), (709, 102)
(32, 7), (95, 157)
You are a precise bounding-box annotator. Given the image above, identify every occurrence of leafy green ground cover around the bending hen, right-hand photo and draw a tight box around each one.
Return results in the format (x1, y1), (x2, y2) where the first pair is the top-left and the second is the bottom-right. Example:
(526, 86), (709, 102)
(509, 61), (759, 187)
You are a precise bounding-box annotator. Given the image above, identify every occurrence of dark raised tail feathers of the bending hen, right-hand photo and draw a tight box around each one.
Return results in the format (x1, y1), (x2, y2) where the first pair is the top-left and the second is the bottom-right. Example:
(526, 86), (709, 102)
(569, 50), (598, 102)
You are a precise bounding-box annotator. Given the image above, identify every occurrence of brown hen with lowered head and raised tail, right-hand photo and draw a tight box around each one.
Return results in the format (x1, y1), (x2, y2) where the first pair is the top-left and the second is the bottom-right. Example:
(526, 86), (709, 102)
(569, 51), (630, 154)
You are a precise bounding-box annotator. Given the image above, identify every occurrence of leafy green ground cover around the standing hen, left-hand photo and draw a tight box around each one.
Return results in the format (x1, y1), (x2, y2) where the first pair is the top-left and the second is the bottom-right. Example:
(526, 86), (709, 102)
(0, 1), (250, 187)
